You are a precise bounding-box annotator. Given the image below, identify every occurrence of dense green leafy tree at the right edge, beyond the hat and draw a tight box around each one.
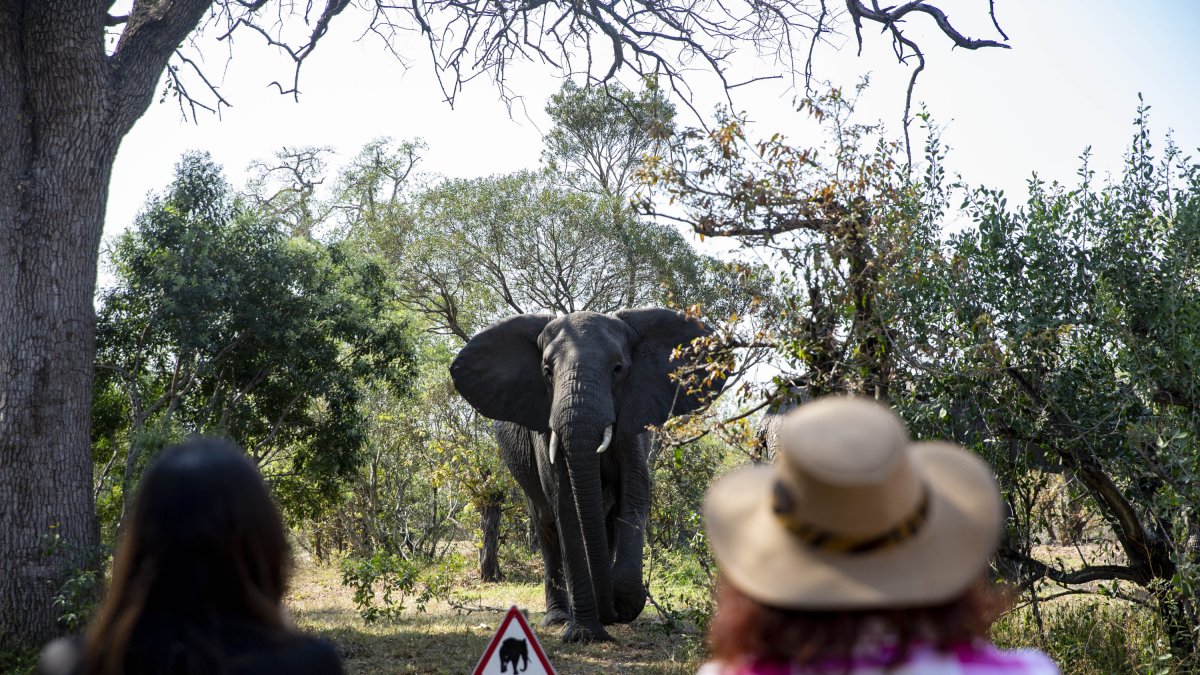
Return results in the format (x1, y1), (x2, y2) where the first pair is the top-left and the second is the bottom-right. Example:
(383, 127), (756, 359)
(908, 108), (1200, 656)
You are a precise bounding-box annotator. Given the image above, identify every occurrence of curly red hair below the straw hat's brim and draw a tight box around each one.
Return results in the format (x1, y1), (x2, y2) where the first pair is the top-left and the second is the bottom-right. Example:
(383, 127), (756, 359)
(708, 571), (1008, 667)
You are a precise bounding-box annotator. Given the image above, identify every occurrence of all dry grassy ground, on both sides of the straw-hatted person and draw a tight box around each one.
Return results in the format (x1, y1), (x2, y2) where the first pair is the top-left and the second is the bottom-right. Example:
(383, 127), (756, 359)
(288, 546), (1190, 675)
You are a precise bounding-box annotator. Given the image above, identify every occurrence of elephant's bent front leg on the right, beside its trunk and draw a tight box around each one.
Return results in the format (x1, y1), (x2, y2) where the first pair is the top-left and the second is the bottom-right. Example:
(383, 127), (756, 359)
(612, 435), (650, 623)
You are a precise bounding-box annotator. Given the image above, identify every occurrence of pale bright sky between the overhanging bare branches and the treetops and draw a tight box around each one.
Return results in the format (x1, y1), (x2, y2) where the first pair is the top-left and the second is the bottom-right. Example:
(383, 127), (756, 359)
(104, 0), (1200, 241)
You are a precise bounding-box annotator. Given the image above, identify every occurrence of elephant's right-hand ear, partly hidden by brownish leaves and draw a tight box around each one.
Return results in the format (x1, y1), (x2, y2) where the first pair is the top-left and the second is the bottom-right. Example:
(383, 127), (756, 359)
(616, 309), (724, 435)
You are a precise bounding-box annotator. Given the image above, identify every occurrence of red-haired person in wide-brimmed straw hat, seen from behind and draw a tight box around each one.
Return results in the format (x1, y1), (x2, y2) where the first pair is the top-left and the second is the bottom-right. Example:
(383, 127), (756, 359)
(700, 398), (1058, 675)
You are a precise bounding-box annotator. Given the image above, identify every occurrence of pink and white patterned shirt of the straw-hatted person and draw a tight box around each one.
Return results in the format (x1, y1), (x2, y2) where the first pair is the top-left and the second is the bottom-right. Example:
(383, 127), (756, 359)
(696, 643), (1058, 675)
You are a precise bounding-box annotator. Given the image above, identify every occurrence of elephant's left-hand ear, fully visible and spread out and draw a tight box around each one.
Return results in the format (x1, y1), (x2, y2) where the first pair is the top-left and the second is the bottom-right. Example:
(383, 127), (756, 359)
(450, 313), (554, 431)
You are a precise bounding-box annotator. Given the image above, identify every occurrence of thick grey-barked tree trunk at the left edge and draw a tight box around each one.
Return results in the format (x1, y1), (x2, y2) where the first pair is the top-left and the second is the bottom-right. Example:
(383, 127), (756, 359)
(0, 0), (208, 649)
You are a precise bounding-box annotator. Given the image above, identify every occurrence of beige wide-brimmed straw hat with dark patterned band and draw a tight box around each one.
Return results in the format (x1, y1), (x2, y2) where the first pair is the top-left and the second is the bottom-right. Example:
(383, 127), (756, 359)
(704, 398), (1003, 610)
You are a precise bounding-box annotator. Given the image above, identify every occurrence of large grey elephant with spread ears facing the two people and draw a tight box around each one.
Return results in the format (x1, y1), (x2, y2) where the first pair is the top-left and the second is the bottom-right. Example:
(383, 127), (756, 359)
(450, 307), (722, 641)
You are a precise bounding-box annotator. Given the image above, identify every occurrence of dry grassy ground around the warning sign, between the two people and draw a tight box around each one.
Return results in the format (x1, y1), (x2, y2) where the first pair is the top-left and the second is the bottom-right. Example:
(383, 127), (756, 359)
(287, 562), (703, 675)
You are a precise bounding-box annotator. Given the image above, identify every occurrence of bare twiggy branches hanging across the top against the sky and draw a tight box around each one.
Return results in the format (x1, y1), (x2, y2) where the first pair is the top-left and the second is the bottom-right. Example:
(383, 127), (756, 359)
(150, 0), (1007, 139)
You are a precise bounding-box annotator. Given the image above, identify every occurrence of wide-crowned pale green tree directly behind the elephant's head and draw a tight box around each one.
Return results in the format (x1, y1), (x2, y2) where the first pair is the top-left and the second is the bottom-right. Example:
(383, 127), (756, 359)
(364, 165), (736, 341)
